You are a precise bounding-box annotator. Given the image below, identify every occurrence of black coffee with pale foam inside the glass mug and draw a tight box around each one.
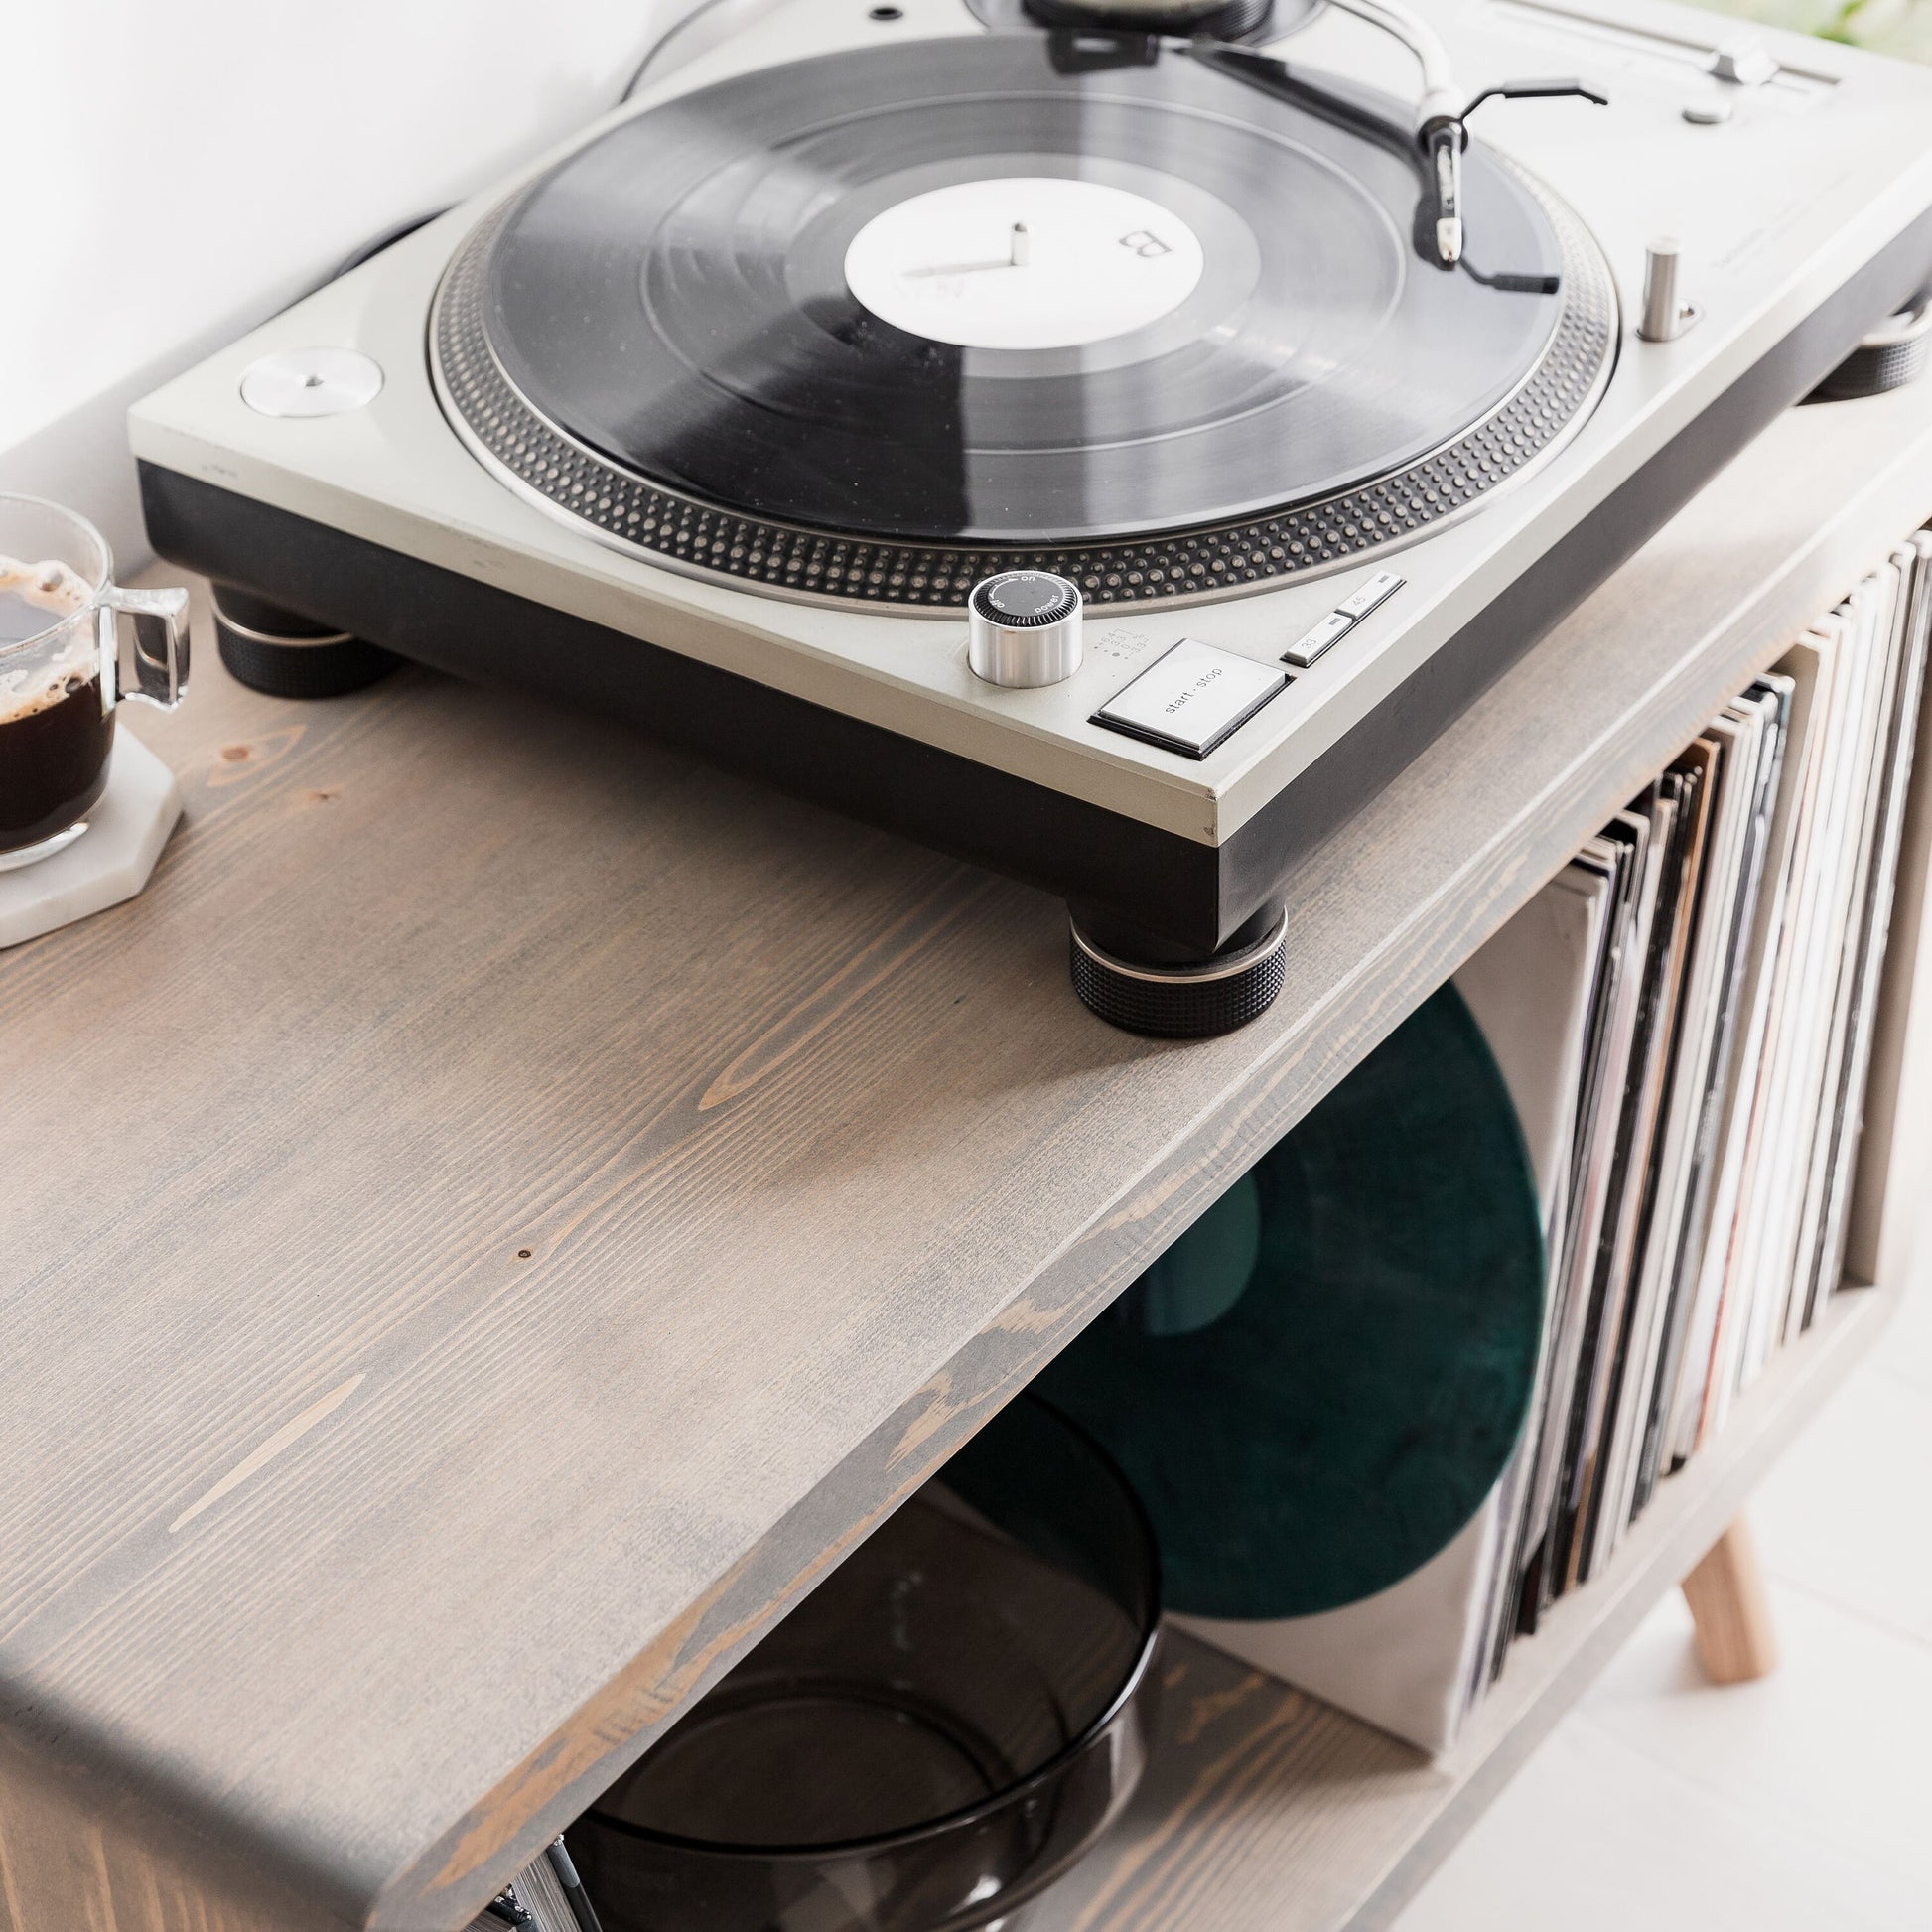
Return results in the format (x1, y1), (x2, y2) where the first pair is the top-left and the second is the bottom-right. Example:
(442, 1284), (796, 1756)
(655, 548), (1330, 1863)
(0, 556), (114, 854)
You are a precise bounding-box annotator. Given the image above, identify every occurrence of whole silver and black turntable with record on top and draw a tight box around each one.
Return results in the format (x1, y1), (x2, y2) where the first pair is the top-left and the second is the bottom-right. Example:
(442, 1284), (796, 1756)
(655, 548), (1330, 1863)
(131, 0), (1932, 1034)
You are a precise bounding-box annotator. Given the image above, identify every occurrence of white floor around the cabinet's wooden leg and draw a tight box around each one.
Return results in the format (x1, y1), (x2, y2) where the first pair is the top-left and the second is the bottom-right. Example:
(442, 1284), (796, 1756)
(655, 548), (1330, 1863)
(1397, 1283), (1932, 1932)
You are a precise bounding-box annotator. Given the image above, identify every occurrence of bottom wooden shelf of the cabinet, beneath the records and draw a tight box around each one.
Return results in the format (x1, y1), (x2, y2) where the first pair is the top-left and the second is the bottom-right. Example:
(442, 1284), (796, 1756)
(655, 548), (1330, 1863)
(1024, 1289), (1897, 1932)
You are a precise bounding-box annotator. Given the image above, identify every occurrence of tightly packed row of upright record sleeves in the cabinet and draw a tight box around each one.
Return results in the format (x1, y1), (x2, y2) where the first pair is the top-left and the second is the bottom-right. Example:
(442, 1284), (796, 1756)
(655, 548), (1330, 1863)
(1470, 533), (1932, 1691)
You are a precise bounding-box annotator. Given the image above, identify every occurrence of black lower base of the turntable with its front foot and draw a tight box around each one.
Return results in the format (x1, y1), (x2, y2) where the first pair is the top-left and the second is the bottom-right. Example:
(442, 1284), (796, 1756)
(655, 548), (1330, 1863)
(139, 212), (1932, 1034)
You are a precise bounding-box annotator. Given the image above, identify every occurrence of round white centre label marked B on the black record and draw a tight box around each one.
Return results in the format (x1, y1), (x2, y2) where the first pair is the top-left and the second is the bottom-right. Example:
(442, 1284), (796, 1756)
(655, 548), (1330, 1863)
(846, 176), (1201, 349)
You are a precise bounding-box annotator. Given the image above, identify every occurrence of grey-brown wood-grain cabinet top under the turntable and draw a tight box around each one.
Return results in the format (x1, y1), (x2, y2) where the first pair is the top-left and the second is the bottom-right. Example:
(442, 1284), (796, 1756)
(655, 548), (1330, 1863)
(11, 390), (1932, 1932)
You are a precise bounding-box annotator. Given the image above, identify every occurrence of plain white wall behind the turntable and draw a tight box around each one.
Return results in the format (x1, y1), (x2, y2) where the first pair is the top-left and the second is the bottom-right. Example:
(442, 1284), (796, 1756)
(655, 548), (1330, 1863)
(0, 0), (688, 570)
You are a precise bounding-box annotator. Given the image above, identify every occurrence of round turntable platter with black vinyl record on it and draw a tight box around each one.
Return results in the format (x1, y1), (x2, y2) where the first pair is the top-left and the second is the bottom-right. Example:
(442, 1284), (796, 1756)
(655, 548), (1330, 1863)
(433, 35), (1613, 605)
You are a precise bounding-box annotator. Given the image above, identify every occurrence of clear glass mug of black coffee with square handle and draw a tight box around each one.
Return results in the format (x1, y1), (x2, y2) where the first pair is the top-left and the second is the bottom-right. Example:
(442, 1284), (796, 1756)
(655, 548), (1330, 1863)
(0, 496), (188, 872)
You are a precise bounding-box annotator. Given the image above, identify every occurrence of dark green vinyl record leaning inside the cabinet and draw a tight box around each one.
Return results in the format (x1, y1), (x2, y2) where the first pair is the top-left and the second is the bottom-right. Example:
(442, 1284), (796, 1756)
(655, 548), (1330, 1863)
(1039, 987), (1544, 1617)
